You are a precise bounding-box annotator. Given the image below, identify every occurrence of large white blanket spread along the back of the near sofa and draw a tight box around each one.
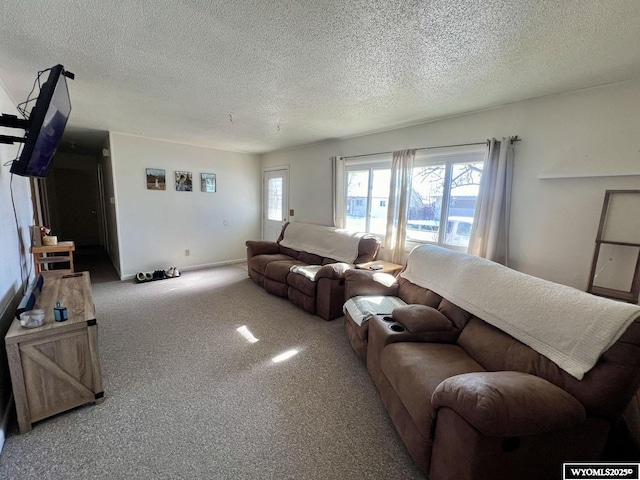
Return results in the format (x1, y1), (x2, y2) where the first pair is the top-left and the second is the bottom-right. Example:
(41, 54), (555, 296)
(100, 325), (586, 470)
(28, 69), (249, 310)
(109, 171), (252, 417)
(400, 245), (640, 380)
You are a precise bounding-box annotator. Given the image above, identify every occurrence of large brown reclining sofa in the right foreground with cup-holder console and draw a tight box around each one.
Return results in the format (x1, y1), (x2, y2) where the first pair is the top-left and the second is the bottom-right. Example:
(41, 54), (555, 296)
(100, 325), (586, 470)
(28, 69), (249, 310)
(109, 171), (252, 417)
(345, 247), (640, 480)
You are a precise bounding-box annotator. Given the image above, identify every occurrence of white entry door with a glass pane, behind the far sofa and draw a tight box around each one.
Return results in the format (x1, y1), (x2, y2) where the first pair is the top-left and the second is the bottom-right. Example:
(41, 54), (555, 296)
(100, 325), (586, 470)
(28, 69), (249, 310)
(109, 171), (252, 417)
(262, 168), (289, 241)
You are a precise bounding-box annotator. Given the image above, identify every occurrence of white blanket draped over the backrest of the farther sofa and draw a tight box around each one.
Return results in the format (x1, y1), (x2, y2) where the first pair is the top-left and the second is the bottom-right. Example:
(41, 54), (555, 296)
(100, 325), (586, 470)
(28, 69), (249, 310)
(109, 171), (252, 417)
(280, 222), (366, 263)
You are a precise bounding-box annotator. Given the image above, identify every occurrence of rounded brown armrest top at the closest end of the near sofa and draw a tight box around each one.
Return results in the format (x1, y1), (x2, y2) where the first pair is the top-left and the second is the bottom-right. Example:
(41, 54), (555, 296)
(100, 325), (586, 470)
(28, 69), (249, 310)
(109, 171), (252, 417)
(431, 371), (586, 437)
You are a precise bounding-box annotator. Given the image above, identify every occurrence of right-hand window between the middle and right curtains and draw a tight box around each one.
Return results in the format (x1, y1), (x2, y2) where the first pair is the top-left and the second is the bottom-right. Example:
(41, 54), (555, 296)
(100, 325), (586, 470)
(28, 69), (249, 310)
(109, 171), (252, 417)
(407, 153), (484, 250)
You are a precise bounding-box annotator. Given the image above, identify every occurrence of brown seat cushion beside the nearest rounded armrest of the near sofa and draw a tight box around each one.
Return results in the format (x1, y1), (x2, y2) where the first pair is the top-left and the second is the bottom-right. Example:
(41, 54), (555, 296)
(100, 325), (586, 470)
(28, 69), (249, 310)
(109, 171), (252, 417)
(380, 342), (485, 438)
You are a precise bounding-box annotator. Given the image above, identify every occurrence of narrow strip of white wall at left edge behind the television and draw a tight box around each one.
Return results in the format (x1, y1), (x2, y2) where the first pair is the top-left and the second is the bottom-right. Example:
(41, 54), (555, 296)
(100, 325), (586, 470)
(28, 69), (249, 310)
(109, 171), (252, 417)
(0, 81), (33, 450)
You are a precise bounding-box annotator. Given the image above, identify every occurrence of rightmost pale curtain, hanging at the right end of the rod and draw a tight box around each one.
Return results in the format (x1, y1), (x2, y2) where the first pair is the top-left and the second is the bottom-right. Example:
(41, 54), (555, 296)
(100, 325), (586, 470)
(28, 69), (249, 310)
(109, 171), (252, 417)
(469, 137), (516, 265)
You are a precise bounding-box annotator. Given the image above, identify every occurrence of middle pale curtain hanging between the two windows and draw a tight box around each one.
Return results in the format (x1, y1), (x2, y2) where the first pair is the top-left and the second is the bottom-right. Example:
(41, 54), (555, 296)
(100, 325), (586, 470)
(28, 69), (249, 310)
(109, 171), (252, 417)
(384, 149), (416, 264)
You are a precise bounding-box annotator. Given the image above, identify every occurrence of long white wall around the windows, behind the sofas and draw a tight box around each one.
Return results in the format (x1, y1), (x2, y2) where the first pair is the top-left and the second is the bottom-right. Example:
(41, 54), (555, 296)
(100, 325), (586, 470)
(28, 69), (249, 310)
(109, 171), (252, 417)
(262, 81), (640, 290)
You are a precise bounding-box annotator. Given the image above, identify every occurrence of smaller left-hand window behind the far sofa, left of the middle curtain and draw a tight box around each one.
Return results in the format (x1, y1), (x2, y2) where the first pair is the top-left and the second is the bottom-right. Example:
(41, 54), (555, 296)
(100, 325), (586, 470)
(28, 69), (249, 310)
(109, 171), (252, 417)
(345, 163), (391, 235)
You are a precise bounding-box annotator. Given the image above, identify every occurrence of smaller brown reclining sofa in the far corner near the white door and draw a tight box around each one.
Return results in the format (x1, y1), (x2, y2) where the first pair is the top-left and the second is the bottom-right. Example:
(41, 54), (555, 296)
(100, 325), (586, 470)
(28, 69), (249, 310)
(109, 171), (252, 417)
(246, 223), (380, 320)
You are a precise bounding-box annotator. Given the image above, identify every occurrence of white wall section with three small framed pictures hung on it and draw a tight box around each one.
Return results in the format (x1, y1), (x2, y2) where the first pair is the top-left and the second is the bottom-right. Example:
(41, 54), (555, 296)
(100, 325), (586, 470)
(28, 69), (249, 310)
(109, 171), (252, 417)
(111, 133), (261, 277)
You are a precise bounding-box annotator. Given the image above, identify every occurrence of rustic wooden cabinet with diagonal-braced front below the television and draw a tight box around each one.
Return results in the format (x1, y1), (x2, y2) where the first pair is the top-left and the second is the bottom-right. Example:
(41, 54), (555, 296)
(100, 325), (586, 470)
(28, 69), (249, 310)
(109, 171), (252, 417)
(5, 272), (104, 433)
